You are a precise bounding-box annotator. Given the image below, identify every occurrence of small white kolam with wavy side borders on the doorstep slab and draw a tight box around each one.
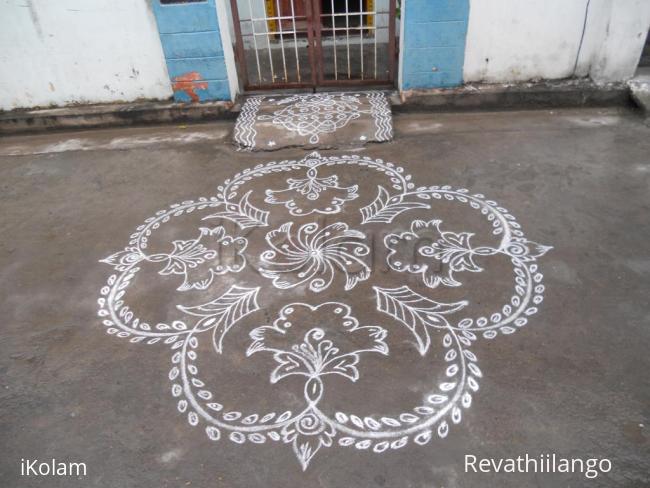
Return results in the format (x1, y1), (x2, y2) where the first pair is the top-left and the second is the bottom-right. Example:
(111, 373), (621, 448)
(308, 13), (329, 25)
(235, 92), (393, 149)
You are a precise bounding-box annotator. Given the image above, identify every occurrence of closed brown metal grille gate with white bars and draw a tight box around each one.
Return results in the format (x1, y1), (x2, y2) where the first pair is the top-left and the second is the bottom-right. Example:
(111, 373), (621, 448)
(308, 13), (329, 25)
(231, 0), (396, 90)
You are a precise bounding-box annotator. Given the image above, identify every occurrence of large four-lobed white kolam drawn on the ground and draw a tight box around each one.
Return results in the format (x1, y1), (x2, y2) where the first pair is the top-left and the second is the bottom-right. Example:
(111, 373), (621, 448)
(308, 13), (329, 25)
(98, 153), (551, 470)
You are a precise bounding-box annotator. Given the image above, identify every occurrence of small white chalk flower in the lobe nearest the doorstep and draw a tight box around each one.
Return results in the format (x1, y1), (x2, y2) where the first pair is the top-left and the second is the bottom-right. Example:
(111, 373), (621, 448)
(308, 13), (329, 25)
(264, 168), (359, 215)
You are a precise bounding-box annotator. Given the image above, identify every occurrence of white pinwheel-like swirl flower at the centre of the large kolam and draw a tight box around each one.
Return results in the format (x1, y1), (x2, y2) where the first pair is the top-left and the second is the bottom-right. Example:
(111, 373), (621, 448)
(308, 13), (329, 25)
(260, 222), (370, 292)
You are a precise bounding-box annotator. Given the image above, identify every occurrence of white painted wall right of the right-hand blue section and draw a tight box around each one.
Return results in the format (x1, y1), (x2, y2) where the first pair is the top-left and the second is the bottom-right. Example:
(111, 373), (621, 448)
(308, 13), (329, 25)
(464, 0), (650, 83)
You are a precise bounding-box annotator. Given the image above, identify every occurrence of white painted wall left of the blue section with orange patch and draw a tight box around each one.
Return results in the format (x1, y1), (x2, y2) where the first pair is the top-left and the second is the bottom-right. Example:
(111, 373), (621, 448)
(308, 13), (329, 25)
(0, 0), (172, 110)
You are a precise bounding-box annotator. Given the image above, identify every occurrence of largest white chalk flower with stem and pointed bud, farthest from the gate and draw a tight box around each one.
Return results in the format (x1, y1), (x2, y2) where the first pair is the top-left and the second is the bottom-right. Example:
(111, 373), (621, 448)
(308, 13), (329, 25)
(246, 302), (388, 470)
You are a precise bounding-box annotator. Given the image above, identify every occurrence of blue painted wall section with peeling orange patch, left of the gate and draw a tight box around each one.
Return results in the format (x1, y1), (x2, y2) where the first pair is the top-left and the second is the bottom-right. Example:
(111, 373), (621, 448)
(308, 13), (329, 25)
(151, 0), (230, 102)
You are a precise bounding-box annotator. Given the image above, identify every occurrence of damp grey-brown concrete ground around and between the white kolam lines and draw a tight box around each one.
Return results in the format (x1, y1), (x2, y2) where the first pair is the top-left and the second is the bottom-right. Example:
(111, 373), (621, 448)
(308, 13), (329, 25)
(0, 109), (650, 488)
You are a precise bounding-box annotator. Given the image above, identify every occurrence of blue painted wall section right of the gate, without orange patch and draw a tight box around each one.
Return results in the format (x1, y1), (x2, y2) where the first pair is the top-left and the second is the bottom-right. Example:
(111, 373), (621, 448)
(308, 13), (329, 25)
(402, 0), (469, 90)
